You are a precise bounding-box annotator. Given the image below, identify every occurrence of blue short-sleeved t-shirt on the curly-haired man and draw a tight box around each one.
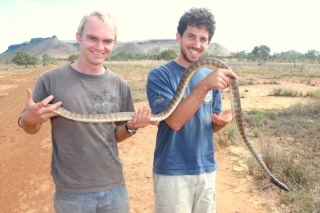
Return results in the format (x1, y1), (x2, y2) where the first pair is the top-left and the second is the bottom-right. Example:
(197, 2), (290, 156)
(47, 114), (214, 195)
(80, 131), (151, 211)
(147, 60), (222, 175)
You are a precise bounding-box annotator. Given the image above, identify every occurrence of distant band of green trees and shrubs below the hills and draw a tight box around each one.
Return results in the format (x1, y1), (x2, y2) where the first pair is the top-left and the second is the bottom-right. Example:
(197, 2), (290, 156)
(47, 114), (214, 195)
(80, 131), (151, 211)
(0, 44), (320, 67)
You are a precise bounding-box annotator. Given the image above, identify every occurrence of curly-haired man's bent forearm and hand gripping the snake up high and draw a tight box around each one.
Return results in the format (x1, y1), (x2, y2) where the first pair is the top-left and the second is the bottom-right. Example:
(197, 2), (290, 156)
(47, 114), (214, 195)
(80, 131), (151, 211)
(165, 69), (237, 131)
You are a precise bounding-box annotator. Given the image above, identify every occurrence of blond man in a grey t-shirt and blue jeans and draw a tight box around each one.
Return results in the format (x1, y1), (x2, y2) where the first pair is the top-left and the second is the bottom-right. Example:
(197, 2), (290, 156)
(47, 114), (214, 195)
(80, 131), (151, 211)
(18, 12), (156, 213)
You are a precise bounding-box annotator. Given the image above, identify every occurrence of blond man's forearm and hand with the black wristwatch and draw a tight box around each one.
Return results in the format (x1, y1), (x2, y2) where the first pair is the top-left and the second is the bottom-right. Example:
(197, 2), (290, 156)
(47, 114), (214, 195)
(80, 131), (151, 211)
(115, 106), (159, 142)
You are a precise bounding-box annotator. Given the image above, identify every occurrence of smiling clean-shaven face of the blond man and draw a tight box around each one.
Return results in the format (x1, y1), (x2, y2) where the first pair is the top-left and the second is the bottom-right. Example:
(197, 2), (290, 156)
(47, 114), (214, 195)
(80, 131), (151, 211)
(77, 17), (115, 65)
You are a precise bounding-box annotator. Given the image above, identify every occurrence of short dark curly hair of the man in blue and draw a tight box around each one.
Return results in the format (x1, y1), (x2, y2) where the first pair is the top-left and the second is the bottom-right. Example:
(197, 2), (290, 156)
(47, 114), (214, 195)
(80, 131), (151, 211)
(177, 7), (216, 41)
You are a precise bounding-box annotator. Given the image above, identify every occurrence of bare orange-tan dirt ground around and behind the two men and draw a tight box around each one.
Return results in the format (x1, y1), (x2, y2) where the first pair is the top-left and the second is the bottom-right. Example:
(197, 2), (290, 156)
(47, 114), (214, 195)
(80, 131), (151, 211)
(0, 64), (319, 213)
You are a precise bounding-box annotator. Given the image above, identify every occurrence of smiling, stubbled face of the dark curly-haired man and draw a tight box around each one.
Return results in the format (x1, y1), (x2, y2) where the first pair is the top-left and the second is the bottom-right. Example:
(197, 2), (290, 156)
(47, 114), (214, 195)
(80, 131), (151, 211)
(177, 26), (210, 63)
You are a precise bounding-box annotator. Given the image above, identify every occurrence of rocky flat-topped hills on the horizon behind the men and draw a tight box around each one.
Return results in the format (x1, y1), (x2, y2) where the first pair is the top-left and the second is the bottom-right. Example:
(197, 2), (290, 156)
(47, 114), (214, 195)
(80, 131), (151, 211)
(0, 36), (231, 58)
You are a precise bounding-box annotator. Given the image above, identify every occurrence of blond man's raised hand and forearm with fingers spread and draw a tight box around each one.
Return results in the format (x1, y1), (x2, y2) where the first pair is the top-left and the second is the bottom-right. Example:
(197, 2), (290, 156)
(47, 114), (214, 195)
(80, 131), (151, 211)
(18, 88), (62, 134)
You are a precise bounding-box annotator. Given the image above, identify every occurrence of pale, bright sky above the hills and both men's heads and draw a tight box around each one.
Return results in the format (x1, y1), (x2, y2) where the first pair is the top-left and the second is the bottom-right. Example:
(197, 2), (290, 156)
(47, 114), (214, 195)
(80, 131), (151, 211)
(0, 0), (320, 53)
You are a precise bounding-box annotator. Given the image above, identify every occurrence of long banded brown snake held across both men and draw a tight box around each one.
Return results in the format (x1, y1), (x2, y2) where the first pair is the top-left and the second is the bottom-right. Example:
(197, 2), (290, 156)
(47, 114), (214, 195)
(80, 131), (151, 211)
(54, 58), (289, 191)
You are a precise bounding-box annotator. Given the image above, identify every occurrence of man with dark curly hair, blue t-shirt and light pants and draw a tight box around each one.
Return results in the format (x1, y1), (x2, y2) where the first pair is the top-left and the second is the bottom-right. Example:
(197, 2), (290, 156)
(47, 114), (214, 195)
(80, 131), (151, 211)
(147, 8), (237, 213)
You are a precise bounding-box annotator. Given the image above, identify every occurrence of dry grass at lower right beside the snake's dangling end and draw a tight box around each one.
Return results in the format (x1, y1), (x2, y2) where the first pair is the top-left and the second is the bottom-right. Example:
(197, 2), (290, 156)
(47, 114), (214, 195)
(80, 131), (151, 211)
(232, 96), (320, 212)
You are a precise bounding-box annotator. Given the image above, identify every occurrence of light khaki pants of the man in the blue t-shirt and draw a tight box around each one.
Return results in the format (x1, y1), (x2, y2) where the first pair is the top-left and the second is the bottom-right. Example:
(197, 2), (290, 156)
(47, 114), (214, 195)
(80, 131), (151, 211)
(153, 171), (216, 213)
